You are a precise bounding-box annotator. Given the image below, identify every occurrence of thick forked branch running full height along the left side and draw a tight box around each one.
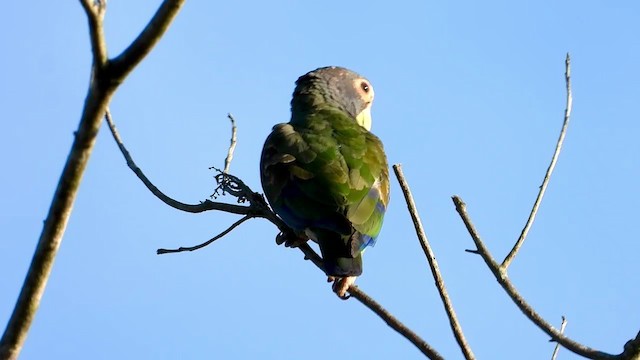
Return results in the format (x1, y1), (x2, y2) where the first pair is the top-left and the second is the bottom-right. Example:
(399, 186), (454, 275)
(0, 0), (184, 360)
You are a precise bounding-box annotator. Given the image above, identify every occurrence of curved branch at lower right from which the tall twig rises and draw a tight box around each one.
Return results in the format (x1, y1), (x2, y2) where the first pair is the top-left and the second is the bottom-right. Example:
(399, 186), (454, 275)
(452, 196), (640, 360)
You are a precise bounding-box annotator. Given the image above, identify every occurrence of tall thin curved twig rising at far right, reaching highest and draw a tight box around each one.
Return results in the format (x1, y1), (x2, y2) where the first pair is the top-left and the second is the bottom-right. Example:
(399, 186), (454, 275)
(500, 53), (573, 270)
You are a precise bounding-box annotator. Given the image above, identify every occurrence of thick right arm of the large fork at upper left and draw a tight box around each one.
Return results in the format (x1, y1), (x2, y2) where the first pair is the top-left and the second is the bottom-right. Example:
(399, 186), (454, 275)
(110, 0), (185, 81)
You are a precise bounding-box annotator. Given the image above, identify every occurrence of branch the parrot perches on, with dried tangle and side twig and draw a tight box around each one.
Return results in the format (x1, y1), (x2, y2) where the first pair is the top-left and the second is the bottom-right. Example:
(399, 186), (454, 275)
(106, 112), (443, 360)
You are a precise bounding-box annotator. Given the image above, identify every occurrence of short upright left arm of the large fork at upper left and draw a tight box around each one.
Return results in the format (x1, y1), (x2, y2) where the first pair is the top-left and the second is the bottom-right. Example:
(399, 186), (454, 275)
(80, 0), (109, 68)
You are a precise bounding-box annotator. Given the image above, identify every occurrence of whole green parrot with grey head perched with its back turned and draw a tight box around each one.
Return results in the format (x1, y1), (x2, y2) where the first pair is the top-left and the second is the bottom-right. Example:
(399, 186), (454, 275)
(260, 66), (389, 298)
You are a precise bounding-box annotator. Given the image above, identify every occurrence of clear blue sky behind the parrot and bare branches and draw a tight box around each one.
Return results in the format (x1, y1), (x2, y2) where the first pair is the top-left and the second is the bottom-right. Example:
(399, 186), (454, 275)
(0, 1), (640, 360)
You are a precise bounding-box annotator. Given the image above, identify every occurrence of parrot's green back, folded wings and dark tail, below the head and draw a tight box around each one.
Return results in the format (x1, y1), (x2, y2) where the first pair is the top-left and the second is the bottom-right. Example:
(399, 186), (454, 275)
(261, 109), (389, 276)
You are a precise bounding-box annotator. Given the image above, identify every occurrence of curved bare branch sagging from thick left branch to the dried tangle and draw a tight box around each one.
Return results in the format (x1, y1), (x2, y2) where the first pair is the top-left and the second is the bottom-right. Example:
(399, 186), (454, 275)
(105, 109), (250, 215)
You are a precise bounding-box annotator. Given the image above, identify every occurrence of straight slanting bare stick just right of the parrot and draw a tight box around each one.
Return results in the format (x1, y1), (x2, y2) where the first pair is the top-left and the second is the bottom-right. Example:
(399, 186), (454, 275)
(393, 164), (475, 360)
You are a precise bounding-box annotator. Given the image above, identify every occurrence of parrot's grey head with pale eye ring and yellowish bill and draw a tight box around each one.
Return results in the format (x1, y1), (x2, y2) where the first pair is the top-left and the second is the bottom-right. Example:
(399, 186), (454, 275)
(291, 66), (374, 130)
